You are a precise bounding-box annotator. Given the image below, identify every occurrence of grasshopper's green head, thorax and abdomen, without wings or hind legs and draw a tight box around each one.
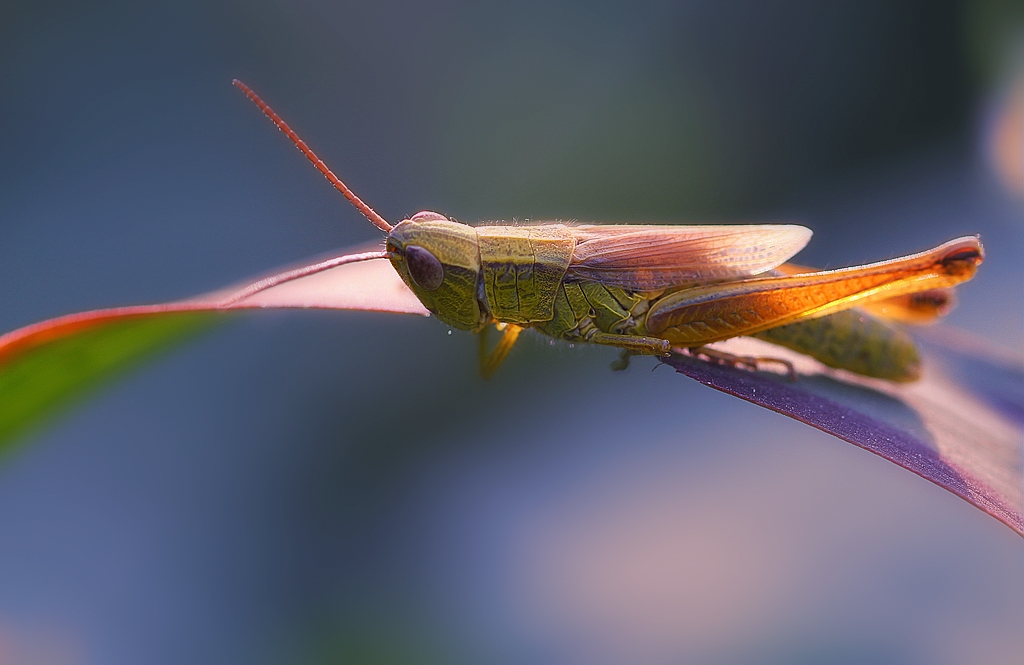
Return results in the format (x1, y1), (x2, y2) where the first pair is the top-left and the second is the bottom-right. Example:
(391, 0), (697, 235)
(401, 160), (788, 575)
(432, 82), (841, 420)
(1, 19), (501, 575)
(387, 218), (919, 381)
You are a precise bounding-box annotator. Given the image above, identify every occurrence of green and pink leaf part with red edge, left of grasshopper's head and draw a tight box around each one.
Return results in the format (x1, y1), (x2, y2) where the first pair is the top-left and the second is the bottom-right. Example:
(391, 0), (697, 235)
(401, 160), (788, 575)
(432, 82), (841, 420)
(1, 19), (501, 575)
(0, 253), (428, 453)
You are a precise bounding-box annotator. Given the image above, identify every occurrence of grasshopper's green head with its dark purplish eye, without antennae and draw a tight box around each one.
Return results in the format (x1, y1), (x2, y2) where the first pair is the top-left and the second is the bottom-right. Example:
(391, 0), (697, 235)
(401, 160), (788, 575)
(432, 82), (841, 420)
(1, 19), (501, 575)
(387, 212), (485, 330)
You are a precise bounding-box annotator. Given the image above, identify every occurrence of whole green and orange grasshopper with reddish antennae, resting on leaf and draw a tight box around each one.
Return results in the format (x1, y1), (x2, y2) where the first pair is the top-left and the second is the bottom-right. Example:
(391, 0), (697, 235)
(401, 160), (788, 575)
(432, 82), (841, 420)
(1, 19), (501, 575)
(231, 80), (983, 381)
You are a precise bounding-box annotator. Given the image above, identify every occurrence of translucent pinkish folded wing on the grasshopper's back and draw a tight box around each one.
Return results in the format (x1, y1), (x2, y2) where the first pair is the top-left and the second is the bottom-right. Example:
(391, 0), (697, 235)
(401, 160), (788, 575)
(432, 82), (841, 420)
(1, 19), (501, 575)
(566, 224), (811, 291)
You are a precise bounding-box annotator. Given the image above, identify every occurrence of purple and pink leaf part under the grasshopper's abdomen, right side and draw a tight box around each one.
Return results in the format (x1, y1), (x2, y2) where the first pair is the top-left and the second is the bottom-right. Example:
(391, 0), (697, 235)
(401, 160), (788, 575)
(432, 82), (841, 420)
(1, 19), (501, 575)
(665, 333), (1024, 536)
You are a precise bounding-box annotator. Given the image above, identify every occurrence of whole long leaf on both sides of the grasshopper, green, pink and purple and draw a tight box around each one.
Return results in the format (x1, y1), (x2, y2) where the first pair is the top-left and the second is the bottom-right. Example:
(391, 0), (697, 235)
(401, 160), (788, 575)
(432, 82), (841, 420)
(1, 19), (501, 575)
(0, 247), (1024, 535)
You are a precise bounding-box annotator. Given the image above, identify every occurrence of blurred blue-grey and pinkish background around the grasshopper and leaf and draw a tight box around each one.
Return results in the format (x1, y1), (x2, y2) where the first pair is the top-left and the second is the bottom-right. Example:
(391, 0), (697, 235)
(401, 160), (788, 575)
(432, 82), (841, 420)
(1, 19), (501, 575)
(0, 0), (1024, 665)
